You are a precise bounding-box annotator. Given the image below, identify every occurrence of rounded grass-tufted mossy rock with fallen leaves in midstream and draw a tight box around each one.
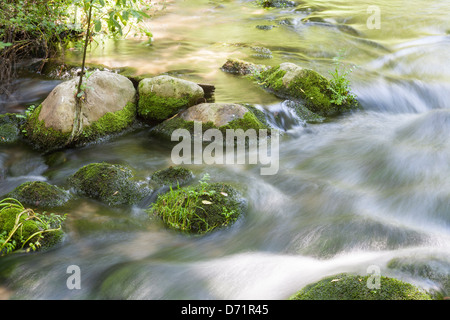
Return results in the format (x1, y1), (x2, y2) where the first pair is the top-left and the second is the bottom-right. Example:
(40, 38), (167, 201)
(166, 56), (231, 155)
(148, 174), (242, 234)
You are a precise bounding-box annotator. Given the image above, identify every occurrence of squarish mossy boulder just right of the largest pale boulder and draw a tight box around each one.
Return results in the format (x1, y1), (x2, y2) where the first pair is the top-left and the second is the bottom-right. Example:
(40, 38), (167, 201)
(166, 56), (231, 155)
(137, 75), (204, 122)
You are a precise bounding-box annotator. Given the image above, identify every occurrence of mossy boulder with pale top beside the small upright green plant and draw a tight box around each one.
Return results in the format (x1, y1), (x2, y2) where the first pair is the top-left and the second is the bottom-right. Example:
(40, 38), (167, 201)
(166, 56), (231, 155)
(255, 62), (358, 117)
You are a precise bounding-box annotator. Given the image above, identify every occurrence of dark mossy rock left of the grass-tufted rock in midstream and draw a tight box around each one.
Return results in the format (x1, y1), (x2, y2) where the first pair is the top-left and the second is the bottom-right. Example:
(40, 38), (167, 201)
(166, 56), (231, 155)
(68, 162), (151, 206)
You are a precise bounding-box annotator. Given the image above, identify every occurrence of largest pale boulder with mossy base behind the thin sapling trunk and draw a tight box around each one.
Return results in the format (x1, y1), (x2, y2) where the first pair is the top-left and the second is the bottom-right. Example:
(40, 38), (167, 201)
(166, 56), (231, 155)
(24, 71), (136, 151)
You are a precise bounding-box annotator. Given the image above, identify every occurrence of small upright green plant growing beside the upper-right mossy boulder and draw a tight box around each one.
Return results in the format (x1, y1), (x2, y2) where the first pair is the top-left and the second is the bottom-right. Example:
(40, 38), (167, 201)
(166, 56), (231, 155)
(328, 51), (356, 106)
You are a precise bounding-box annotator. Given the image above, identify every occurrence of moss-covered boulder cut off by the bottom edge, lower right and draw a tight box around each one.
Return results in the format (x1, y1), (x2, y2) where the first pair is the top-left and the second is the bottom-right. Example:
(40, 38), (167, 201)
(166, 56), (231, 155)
(290, 274), (431, 300)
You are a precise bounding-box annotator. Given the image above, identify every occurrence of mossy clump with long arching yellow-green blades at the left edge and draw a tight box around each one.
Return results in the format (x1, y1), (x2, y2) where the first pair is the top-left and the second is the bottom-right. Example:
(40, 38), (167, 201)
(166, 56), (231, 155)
(0, 198), (65, 255)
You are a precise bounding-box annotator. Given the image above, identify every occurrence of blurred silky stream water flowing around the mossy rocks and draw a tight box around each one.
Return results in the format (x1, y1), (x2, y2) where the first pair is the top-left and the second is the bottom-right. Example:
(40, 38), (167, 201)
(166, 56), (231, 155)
(0, 0), (450, 299)
